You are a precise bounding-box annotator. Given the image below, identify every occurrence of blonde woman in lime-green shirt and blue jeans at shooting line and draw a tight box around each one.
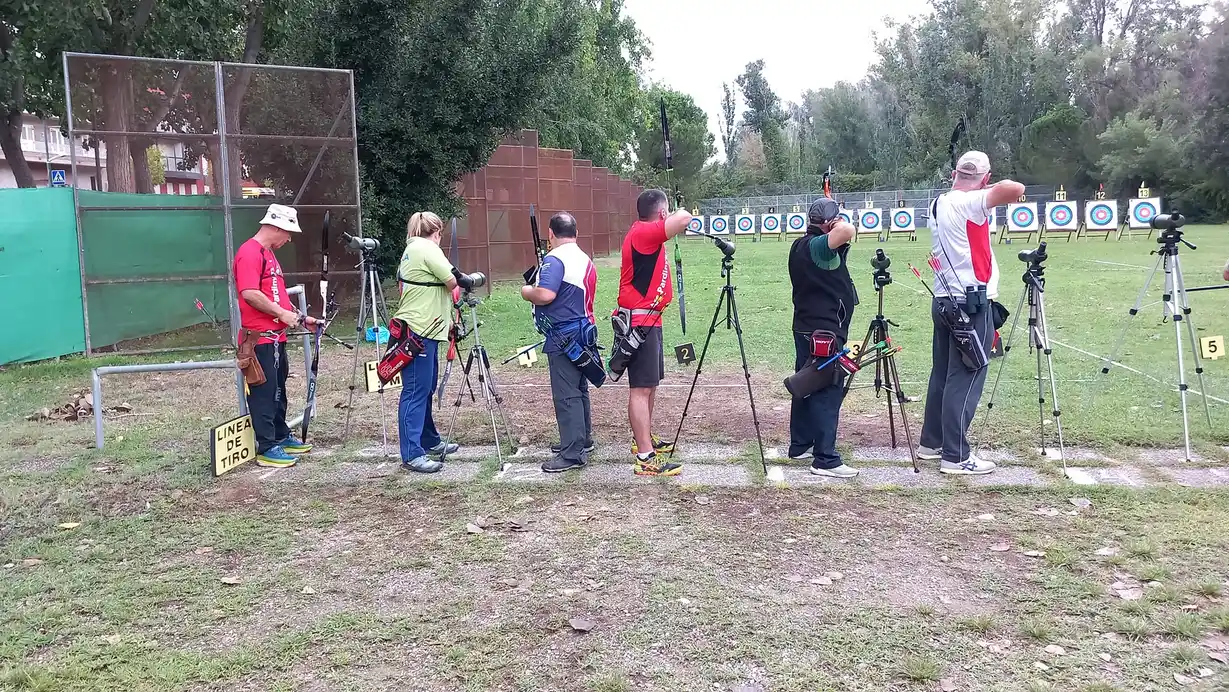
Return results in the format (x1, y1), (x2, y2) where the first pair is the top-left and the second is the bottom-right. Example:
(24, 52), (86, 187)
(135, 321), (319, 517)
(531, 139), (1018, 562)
(393, 211), (457, 473)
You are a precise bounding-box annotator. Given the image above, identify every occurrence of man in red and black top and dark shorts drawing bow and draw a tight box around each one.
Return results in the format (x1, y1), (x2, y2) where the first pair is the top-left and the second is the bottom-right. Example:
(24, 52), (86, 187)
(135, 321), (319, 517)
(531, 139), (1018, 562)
(618, 189), (692, 476)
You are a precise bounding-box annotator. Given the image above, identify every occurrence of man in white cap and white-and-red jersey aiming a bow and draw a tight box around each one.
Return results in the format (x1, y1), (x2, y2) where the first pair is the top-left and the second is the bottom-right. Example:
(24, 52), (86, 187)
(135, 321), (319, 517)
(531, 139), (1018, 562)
(918, 151), (1024, 476)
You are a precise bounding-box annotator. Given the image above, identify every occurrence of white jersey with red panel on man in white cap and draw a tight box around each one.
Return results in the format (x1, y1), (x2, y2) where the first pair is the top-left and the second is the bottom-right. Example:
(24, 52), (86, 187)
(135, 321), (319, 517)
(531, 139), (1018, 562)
(930, 189), (998, 301)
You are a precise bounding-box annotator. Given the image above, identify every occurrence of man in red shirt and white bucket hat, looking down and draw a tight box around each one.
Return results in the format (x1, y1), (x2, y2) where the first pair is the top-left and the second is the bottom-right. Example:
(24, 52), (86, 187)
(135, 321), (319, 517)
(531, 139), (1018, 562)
(235, 204), (316, 468)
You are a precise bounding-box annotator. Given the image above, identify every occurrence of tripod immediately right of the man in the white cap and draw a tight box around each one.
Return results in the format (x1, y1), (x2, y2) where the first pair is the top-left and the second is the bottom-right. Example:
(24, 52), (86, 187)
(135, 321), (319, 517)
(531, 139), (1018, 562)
(980, 249), (1067, 471)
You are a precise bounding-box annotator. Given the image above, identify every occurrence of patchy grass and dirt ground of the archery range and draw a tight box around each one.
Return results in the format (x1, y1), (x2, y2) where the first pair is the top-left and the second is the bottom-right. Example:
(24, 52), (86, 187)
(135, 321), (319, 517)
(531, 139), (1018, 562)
(0, 227), (1229, 692)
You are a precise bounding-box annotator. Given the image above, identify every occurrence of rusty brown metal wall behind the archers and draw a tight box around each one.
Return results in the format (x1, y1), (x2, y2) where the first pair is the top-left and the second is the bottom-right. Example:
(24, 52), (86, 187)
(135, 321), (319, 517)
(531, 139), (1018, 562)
(457, 130), (644, 279)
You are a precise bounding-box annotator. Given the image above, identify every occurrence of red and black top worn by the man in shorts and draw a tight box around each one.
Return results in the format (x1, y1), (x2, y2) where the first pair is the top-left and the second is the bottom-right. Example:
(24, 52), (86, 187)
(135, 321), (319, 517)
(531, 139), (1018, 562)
(618, 219), (675, 327)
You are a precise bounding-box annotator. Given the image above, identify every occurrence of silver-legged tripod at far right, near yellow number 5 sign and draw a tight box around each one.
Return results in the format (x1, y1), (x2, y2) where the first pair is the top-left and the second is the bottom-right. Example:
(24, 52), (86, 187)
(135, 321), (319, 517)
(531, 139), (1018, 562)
(1101, 229), (1212, 461)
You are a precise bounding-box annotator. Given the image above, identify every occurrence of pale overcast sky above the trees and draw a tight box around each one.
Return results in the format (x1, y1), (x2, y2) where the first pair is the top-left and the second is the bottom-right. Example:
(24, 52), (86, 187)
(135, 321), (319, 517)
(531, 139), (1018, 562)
(623, 0), (929, 156)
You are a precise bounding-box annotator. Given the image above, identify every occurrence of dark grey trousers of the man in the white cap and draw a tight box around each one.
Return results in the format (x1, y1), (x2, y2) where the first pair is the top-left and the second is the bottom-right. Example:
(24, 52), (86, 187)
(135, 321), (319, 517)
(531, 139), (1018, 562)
(919, 297), (994, 462)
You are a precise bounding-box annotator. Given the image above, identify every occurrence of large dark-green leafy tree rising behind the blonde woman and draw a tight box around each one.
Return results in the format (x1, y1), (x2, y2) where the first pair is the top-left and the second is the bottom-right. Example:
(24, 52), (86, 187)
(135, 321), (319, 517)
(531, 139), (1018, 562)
(283, 0), (584, 247)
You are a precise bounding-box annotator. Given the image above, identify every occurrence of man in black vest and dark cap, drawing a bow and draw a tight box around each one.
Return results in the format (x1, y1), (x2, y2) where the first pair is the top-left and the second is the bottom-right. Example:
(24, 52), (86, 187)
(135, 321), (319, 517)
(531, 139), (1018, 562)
(789, 198), (858, 478)
